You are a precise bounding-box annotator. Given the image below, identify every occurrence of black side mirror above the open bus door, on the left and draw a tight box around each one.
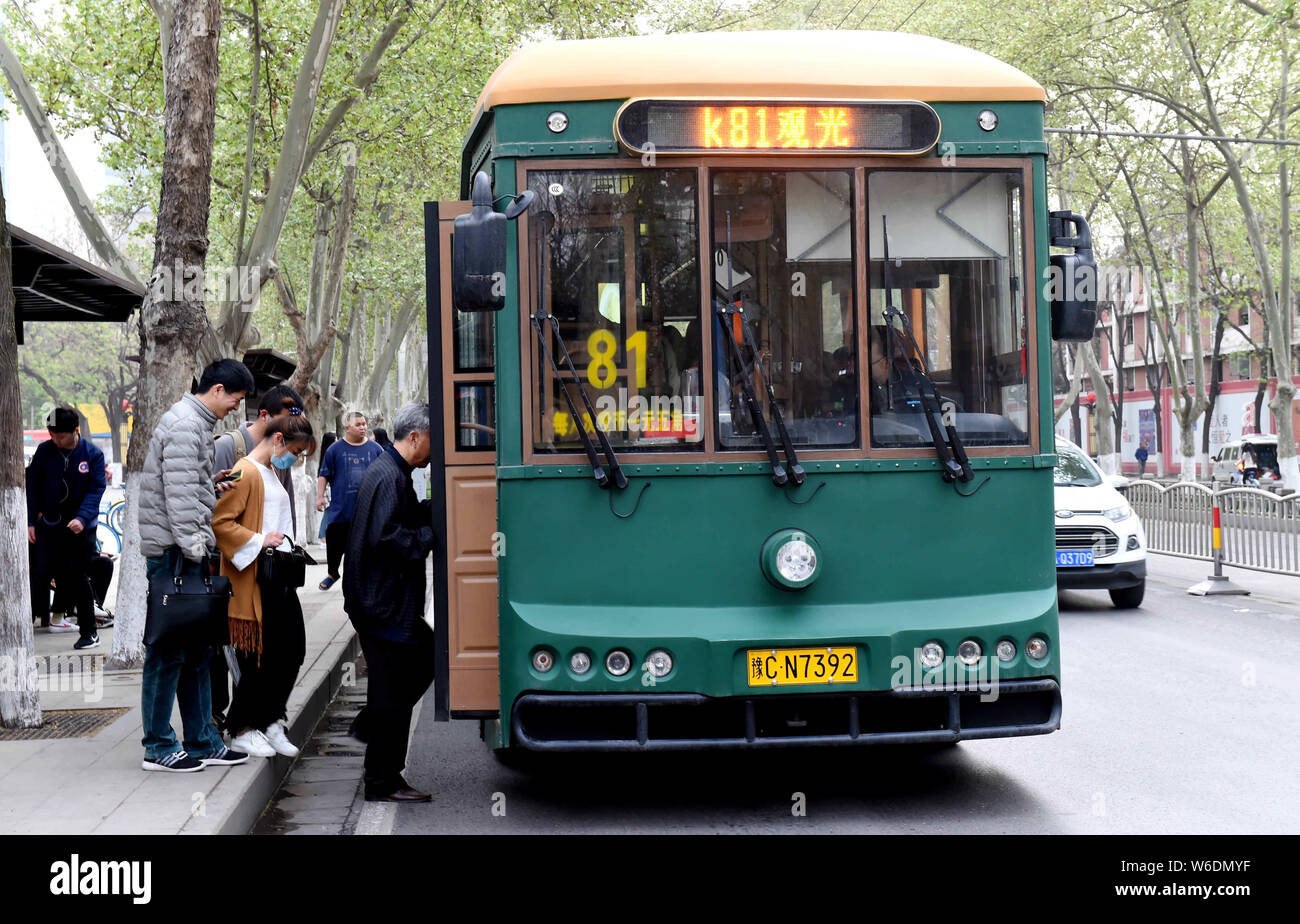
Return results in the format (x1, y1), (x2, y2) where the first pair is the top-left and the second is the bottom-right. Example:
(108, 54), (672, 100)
(451, 172), (533, 312)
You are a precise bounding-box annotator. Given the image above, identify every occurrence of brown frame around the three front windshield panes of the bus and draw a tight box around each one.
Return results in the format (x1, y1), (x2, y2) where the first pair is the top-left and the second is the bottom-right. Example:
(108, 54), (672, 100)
(512, 155), (1041, 467)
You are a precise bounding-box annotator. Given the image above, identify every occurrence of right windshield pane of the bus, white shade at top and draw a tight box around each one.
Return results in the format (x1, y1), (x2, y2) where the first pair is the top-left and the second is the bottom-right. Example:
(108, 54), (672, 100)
(867, 168), (1030, 446)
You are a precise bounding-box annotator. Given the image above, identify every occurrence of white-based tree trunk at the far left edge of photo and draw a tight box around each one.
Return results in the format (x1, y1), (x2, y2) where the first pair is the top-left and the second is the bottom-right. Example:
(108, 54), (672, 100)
(0, 170), (40, 728)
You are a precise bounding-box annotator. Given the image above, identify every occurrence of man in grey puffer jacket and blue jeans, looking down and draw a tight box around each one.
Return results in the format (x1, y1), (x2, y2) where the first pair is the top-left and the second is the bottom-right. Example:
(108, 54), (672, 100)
(139, 359), (254, 773)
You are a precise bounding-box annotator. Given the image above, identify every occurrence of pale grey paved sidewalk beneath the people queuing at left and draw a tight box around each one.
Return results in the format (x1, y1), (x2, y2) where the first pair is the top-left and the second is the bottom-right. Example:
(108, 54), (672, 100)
(0, 561), (359, 834)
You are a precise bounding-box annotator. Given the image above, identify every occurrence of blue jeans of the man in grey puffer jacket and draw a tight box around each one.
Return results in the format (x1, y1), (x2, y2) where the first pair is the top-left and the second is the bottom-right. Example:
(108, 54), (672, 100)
(140, 547), (225, 760)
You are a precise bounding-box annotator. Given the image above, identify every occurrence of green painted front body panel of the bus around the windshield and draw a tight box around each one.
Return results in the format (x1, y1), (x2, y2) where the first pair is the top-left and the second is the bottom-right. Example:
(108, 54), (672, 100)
(434, 90), (1060, 746)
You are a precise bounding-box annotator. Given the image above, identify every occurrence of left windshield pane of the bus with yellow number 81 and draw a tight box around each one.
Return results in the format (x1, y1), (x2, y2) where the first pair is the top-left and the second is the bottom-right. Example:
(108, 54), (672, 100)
(528, 169), (703, 451)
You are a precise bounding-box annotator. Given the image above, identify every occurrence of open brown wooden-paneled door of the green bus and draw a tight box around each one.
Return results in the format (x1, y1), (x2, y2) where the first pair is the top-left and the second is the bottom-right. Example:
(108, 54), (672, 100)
(425, 201), (499, 721)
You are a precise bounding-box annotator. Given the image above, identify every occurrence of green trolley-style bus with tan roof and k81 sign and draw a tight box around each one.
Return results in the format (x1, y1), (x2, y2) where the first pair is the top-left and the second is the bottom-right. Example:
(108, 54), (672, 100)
(425, 31), (1096, 751)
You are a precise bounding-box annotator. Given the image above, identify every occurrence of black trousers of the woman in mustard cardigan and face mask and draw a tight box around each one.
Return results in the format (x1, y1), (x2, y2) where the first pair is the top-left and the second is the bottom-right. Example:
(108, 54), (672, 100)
(226, 577), (307, 734)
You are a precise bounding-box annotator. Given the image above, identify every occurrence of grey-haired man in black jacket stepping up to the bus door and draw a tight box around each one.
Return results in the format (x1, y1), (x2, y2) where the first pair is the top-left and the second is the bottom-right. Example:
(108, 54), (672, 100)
(343, 404), (434, 802)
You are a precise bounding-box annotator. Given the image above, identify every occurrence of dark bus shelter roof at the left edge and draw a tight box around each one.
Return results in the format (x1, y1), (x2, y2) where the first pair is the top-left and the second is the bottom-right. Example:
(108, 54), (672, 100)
(8, 225), (144, 343)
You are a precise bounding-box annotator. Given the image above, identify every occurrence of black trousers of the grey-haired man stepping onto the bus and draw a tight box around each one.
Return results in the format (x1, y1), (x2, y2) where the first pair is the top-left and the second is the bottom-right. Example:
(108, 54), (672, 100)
(358, 626), (434, 795)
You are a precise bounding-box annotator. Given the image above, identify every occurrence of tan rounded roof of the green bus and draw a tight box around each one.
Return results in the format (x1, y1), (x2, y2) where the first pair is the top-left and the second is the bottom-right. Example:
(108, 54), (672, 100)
(476, 30), (1047, 113)
